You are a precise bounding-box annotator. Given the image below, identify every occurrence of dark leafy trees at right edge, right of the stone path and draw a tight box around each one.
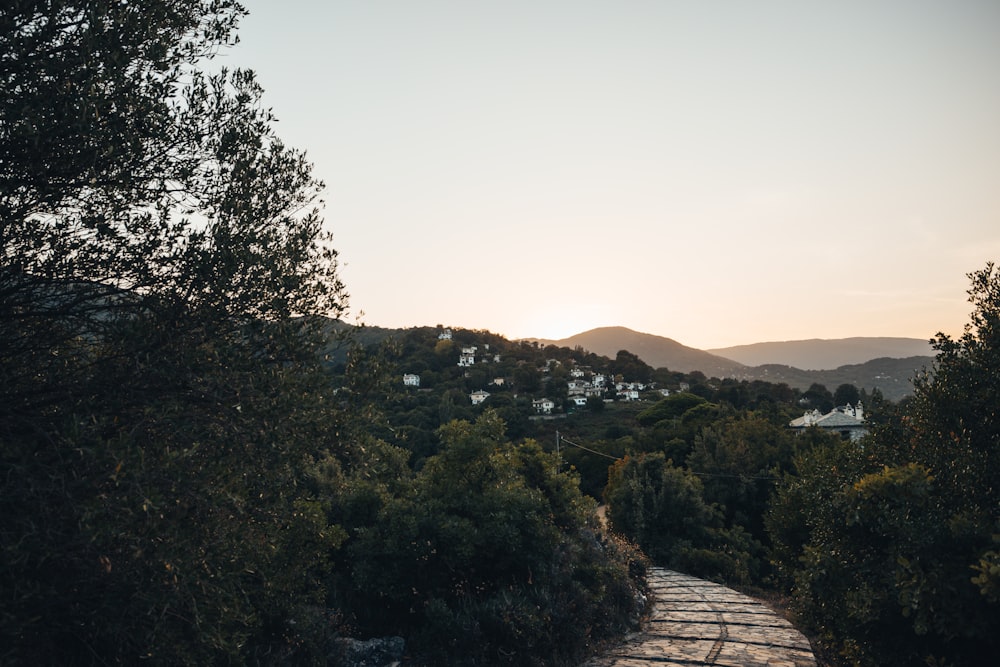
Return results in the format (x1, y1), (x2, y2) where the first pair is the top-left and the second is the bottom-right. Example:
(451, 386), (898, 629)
(769, 263), (1000, 665)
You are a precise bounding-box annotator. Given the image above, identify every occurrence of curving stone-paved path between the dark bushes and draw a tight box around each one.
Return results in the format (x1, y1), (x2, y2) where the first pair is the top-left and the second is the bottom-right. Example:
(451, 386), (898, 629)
(581, 568), (816, 667)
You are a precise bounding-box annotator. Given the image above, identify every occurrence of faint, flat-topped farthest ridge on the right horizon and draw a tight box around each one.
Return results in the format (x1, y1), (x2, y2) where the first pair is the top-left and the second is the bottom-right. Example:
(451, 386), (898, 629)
(708, 338), (934, 370)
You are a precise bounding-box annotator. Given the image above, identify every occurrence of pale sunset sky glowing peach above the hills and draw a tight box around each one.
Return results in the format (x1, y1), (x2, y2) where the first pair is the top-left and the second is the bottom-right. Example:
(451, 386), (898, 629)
(227, 0), (1000, 349)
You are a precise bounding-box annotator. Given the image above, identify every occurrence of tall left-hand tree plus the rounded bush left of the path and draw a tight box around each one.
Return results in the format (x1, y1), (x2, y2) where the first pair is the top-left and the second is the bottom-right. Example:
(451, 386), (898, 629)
(0, 0), (643, 665)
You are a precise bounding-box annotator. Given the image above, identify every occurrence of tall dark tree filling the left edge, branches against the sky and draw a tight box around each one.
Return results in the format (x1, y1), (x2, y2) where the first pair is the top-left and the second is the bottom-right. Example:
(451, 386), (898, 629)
(0, 0), (351, 664)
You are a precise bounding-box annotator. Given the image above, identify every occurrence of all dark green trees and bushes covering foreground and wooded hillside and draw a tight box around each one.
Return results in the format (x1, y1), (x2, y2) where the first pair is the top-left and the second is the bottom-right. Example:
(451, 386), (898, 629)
(0, 0), (1000, 665)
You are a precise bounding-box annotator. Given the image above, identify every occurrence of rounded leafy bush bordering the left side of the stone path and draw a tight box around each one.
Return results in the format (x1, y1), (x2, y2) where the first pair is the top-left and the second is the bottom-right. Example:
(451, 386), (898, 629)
(338, 410), (645, 665)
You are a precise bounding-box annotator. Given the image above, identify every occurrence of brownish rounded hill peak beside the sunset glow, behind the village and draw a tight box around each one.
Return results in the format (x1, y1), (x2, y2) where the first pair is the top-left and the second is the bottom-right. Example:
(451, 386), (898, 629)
(530, 327), (744, 377)
